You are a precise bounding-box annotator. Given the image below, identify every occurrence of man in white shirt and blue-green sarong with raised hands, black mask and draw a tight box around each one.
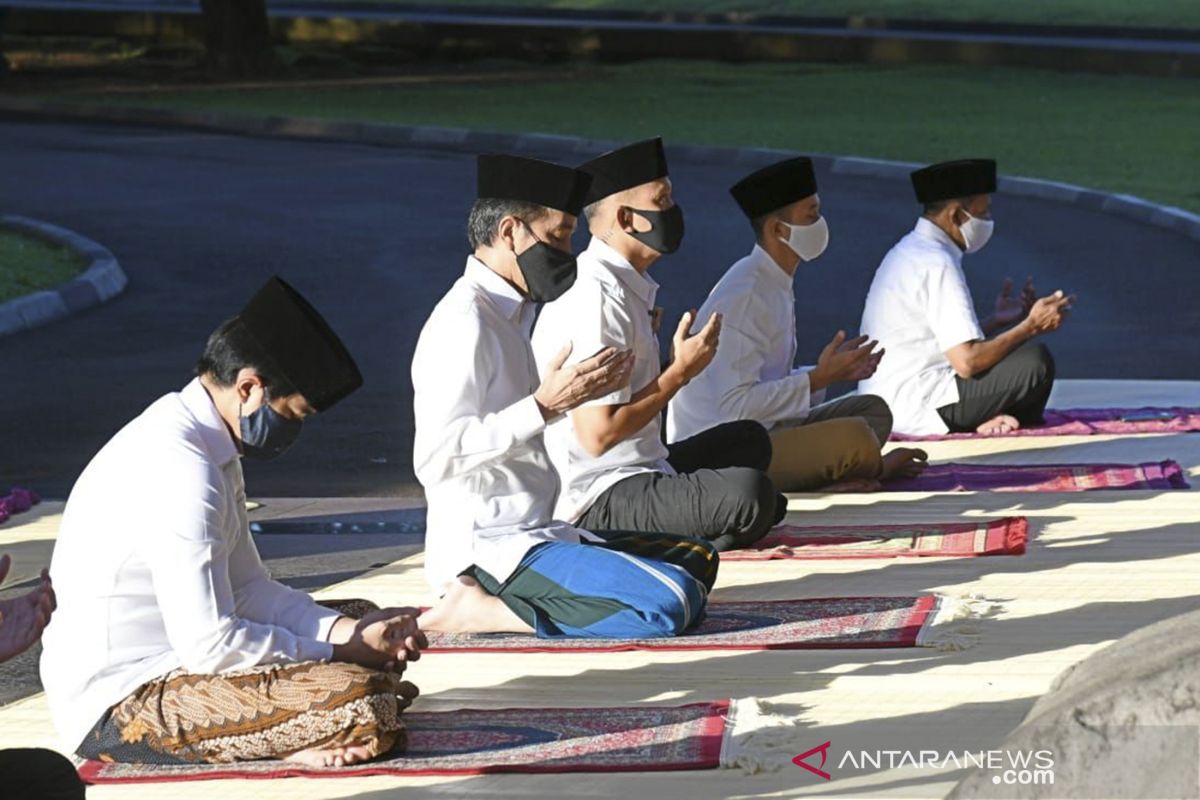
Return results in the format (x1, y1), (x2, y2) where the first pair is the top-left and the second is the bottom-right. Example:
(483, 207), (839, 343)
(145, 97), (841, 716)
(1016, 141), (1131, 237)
(413, 155), (718, 638)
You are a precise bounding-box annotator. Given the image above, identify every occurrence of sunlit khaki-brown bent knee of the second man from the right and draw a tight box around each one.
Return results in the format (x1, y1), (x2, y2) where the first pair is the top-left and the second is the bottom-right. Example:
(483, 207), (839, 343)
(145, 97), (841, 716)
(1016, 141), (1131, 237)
(767, 416), (883, 492)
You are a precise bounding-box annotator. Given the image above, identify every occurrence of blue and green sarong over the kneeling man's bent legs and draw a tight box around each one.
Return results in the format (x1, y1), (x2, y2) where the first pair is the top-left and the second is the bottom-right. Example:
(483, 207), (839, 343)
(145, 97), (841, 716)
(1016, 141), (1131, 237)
(473, 534), (716, 638)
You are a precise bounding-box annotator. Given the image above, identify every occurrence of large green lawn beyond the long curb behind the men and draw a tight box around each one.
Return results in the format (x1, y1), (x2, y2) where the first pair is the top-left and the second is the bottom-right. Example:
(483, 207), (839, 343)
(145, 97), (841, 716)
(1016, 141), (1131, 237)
(51, 61), (1200, 210)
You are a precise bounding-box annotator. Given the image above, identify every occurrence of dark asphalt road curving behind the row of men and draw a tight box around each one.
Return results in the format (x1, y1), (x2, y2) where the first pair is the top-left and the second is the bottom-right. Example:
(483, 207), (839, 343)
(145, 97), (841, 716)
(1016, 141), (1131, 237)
(0, 122), (1200, 503)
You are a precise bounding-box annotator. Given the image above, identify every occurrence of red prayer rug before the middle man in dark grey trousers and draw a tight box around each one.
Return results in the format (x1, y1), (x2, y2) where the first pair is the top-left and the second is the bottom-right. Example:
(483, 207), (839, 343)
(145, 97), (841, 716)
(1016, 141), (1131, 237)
(721, 517), (1028, 561)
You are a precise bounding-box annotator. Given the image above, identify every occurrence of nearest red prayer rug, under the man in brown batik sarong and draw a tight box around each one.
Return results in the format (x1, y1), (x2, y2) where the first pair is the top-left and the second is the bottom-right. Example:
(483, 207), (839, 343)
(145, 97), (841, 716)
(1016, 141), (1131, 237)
(79, 700), (729, 783)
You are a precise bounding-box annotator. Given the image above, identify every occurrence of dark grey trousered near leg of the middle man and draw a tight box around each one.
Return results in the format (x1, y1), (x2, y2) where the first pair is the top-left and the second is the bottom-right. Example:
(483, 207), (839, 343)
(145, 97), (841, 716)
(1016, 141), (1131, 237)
(576, 467), (787, 551)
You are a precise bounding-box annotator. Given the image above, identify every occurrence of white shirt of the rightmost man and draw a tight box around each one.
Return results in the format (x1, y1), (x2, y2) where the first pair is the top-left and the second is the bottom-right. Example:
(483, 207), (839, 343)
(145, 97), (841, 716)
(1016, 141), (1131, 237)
(858, 217), (984, 435)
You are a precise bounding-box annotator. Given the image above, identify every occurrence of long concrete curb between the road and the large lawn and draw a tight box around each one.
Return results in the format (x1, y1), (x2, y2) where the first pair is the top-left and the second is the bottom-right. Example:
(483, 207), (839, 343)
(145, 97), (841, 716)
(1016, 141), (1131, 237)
(9, 97), (1200, 242)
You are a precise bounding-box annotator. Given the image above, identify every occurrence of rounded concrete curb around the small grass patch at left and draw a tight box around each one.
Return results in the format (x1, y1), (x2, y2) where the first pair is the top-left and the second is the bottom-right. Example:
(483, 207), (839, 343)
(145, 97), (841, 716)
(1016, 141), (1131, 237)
(0, 215), (128, 336)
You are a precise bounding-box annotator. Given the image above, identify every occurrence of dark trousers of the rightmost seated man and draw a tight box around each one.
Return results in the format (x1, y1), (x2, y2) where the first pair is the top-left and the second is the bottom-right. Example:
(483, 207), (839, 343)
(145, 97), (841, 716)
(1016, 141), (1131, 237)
(937, 342), (1054, 433)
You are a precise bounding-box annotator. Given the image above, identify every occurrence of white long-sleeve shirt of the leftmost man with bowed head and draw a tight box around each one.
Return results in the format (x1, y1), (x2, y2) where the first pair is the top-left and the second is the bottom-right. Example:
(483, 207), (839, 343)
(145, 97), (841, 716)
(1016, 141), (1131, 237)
(41, 379), (337, 750)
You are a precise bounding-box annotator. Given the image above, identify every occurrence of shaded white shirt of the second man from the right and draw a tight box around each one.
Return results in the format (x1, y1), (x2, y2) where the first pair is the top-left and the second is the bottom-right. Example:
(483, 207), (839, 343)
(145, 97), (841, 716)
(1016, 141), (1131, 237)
(667, 245), (824, 441)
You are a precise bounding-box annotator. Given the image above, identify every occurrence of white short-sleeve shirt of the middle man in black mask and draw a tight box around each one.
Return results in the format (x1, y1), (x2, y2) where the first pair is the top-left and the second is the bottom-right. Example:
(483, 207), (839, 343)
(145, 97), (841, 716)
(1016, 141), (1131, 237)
(533, 237), (674, 522)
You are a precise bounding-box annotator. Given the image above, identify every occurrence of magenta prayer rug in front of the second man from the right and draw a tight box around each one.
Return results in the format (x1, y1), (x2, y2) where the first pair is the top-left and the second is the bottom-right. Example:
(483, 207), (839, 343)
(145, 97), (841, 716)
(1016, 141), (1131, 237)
(883, 461), (1188, 492)
